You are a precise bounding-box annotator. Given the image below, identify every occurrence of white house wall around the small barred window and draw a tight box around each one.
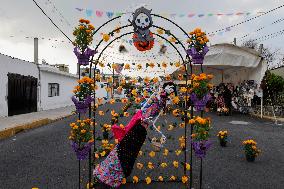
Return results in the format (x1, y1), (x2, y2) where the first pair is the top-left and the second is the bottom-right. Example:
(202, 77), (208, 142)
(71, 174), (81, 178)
(40, 66), (78, 110)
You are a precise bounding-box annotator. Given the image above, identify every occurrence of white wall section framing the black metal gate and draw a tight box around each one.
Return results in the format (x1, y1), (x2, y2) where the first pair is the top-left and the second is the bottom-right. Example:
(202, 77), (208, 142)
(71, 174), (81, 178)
(0, 54), (38, 117)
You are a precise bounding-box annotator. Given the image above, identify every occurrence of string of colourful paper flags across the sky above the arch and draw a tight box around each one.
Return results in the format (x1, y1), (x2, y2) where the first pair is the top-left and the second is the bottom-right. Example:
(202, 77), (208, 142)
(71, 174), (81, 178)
(75, 7), (265, 19)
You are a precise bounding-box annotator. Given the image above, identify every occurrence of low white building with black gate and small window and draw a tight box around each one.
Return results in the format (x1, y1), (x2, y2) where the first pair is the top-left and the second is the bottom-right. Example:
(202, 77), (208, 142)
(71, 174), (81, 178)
(0, 54), (78, 117)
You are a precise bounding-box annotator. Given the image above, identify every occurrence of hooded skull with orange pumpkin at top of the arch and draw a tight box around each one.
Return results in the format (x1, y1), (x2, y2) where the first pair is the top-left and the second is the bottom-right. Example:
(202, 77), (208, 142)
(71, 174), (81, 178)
(131, 7), (154, 51)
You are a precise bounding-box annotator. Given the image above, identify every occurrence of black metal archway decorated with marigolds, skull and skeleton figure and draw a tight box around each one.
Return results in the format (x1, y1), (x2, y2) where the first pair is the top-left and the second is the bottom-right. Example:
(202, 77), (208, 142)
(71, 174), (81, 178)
(70, 7), (212, 188)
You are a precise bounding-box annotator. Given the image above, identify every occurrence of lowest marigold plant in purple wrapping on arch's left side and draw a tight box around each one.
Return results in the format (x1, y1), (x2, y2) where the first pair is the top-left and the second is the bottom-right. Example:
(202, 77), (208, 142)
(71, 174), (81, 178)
(69, 119), (94, 160)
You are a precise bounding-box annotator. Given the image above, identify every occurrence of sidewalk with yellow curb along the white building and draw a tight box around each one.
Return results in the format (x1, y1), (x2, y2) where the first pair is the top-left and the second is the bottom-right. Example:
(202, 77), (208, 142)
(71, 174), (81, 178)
(0, 106), (75, 139)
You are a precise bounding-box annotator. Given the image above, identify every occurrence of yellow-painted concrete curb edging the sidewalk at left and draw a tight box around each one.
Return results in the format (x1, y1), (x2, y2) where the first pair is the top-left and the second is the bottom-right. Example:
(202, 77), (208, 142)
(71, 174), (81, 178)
(0, 114), (73, 140)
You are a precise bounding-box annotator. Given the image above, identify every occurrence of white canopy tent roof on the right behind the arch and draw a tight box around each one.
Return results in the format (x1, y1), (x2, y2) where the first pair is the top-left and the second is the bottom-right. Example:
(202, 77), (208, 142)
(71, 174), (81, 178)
(193, 44), (267, 85)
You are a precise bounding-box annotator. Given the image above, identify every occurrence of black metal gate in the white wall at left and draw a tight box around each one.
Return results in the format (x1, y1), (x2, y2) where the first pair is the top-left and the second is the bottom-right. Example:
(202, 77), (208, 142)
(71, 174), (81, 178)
(8, 73), (37, 116)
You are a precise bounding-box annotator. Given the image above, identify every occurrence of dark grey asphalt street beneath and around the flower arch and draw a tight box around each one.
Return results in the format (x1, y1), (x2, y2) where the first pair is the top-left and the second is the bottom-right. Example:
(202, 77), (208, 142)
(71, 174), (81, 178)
(0, 102), (284, 189)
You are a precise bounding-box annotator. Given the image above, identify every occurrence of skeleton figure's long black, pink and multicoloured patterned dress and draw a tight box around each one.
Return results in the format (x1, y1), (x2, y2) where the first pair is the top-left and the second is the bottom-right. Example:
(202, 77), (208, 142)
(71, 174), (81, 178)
(94, 93), (165, 188)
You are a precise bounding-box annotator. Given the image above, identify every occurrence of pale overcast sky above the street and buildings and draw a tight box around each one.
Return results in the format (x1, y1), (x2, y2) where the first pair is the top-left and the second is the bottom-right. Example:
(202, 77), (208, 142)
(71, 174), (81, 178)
(0, 0), (284, 73)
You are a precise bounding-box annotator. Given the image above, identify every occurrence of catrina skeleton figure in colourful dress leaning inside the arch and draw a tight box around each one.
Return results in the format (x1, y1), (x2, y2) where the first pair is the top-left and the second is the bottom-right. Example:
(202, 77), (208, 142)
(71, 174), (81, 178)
(94, 83), (176, 188)
